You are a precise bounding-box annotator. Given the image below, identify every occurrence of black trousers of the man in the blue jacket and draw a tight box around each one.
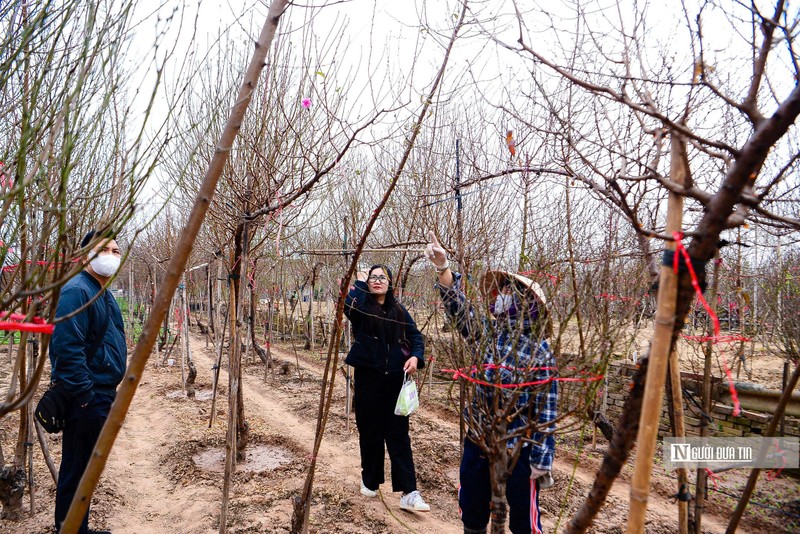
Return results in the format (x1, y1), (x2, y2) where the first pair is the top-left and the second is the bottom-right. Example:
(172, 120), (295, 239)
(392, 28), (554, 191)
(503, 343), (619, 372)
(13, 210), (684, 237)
(55, 394), (114, 534)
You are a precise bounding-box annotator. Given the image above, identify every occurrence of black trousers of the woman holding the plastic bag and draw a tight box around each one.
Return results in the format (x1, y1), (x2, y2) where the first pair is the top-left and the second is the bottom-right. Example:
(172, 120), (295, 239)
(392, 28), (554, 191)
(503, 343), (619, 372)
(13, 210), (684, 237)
(354, 367), (417, 493)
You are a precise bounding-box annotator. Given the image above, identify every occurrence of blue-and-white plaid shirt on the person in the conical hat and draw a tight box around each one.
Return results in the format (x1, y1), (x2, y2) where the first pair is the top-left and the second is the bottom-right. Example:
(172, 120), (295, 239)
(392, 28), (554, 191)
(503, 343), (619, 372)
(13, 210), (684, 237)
(436, 273), (558, 471)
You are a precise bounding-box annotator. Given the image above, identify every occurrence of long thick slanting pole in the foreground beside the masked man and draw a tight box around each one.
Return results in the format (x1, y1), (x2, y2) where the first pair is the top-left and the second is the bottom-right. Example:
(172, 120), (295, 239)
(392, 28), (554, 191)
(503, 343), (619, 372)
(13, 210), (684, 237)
(61, 0), (288, 534)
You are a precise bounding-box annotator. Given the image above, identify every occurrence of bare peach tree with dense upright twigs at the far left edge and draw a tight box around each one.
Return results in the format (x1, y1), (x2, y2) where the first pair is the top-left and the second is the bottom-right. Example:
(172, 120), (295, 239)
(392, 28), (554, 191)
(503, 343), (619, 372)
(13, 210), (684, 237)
(0, 1), (175, 517)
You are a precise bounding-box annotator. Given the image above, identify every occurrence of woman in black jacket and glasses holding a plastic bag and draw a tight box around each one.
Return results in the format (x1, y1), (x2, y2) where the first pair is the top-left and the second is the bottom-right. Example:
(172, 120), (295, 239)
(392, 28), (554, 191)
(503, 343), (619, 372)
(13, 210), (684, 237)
(344, 265), (430, 512)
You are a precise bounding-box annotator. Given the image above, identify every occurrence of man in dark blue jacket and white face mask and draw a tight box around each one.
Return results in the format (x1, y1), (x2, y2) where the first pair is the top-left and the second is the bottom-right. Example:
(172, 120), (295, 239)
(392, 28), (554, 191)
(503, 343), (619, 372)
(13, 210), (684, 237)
(50, 230), (127, 534)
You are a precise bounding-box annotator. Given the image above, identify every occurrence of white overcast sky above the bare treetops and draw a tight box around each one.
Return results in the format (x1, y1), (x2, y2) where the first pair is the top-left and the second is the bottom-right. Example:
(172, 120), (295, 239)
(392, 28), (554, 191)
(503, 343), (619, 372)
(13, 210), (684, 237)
(122, 0), (792, 260)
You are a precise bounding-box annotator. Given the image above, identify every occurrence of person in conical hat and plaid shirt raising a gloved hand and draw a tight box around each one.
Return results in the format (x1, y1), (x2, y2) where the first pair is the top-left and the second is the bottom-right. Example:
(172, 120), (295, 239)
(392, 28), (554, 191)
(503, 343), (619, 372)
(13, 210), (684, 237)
(425, 232), (558, 534)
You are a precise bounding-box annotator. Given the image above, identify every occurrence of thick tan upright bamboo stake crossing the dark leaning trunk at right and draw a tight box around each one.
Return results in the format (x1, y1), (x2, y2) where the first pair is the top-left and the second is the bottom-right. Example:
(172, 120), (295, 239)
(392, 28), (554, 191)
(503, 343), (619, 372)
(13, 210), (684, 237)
(627, 132), (689, 534)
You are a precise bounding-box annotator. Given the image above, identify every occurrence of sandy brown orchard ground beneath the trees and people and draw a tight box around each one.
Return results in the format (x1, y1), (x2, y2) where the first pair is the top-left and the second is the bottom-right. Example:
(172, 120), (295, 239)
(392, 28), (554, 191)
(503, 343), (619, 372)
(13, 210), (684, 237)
(0, 328), (800, 534)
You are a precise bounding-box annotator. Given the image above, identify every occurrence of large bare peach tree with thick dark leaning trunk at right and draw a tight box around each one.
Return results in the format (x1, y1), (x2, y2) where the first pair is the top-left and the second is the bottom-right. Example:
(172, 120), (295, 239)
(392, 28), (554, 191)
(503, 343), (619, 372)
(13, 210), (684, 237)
(466, 0), (800, 532)
